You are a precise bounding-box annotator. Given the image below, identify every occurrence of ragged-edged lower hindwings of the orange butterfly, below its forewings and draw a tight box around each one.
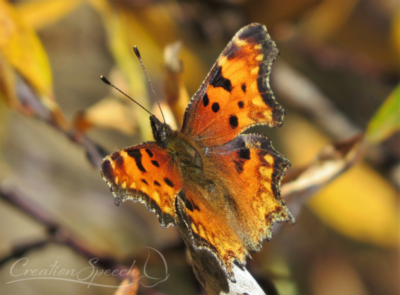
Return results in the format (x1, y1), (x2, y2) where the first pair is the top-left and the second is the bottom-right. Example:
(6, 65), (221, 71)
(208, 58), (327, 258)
(177, 134), (294, 279)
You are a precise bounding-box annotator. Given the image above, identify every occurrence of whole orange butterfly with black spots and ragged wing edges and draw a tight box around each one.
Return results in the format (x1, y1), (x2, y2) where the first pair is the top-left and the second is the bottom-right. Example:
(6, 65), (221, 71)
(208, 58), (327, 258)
(101, 24), (294, 279)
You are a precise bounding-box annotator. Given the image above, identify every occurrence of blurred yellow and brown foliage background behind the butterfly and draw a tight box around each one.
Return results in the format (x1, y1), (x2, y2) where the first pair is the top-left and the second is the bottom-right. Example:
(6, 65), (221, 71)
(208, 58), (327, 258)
(0, 0), (400, 295)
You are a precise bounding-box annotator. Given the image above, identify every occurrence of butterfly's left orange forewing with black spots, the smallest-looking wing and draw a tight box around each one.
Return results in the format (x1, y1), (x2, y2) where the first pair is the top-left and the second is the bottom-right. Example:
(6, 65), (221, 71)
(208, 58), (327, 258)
(101, 142), (182, 227)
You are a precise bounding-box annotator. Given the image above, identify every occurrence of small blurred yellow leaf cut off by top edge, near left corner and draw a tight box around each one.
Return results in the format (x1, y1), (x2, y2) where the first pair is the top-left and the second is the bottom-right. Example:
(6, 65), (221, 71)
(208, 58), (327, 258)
(15, 0), (86, 30)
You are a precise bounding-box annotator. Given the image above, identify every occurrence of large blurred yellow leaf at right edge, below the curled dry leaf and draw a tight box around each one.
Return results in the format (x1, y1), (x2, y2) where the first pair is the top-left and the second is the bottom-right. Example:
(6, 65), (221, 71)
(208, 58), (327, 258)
(308, 163), (399, 246)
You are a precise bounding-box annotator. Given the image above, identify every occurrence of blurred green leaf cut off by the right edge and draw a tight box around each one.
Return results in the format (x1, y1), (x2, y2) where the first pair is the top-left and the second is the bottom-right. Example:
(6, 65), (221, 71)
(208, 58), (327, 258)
(367, 84), (400, 144)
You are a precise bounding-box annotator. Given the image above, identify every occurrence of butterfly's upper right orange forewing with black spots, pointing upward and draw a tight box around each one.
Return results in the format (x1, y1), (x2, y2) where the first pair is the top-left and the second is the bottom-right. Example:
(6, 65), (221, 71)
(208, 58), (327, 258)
(182, 24), (284, 147)
